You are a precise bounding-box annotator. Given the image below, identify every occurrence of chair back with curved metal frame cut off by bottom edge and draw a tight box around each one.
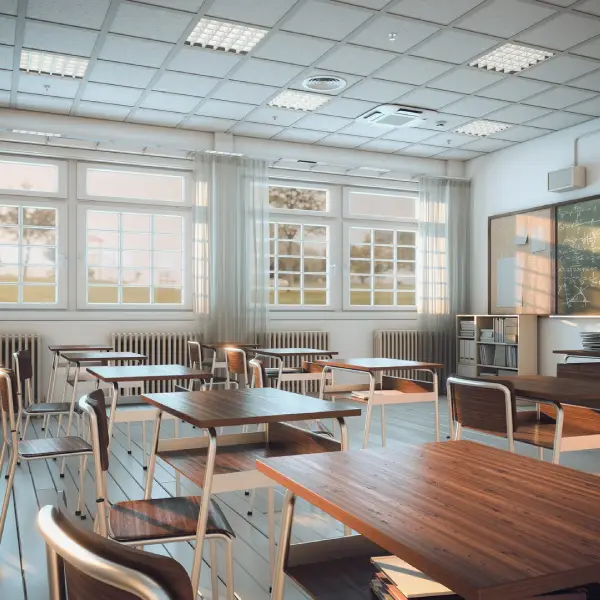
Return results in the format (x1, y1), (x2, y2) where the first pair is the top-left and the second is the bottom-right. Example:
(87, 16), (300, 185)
(37, 506), (196, 600)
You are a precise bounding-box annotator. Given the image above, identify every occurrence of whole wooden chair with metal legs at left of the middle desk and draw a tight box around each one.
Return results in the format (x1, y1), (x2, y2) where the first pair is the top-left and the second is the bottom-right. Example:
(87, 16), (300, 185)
(79, 390), (235, 600)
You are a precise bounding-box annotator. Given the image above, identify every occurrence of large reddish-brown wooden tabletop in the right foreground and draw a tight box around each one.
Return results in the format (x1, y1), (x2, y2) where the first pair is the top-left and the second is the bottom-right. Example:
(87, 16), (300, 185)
(257, 441), (600, 600)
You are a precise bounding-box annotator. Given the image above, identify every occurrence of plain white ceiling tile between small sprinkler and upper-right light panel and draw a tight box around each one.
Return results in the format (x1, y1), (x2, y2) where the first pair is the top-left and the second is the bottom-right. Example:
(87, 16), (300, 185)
(411, 29), (498, 64)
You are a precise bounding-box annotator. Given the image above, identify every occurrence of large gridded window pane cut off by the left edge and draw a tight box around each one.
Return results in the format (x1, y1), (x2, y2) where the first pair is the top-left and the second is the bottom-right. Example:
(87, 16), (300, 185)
(0, 204), (59, 308)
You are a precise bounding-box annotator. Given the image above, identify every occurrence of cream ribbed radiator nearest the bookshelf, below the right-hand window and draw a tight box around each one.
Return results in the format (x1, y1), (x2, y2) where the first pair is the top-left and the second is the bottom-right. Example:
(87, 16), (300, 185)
(373, 330), (456, 393)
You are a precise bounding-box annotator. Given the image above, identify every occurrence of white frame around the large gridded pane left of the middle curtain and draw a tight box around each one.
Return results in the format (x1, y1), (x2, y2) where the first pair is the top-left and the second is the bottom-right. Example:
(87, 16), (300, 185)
(77, 202), (194, 312)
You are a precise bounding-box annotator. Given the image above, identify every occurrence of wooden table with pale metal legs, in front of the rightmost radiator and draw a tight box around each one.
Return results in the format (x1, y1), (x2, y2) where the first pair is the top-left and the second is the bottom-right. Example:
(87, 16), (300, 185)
(315, 358), (444, 448)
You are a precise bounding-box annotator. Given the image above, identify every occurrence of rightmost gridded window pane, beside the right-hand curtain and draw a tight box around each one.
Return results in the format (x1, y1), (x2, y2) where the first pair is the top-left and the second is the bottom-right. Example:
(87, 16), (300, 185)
(347, 226), (416, 308)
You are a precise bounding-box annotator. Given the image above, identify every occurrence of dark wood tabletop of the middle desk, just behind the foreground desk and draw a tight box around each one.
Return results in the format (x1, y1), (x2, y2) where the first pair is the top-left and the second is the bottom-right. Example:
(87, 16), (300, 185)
(142, 388), (361, 428)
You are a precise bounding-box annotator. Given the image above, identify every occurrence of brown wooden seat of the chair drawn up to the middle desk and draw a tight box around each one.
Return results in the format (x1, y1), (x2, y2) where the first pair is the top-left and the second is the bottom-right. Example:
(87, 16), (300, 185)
(109, 496), (235, 543)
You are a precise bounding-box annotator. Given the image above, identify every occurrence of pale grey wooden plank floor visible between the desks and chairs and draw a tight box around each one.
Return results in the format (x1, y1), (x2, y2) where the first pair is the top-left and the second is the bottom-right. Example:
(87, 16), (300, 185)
(0, 402), (600, 600)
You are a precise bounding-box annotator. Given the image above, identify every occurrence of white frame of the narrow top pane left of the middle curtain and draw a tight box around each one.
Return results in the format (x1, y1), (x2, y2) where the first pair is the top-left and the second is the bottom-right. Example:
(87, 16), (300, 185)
(77, 162), (194, 208)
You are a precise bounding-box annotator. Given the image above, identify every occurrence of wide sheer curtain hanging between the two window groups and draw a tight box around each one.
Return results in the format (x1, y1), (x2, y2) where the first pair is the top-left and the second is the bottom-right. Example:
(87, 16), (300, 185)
(194, 154), (269, 342)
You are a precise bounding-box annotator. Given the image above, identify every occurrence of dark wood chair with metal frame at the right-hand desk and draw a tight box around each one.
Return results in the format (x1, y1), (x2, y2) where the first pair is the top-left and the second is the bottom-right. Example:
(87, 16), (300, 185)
(447, 376), (600, 464)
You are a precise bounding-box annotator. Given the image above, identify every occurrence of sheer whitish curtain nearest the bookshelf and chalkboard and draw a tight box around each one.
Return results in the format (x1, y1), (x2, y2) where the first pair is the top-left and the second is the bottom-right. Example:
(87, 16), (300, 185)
(418, 177), (471, 333)
